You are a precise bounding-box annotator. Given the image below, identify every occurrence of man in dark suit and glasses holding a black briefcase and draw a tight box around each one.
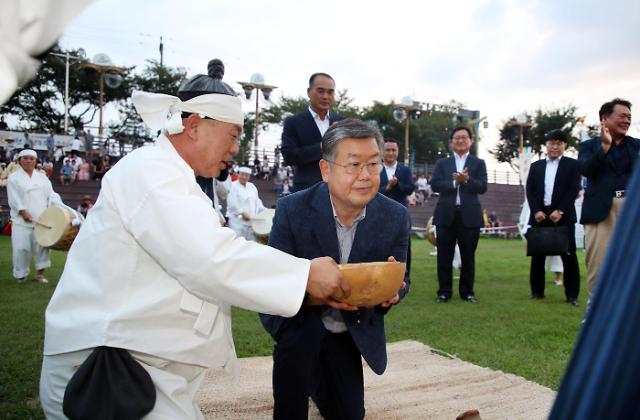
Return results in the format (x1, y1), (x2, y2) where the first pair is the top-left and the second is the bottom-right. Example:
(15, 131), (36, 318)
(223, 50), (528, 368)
(526, 130), (580, 306)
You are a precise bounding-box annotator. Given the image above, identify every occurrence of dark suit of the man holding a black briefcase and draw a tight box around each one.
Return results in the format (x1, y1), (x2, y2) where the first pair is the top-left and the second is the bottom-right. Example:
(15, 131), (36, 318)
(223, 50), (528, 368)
(526, 157), (580, 300)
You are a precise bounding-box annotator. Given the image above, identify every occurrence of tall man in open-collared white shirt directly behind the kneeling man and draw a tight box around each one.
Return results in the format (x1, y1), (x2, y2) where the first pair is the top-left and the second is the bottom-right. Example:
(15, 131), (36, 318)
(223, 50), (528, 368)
(282, 73), (342, 191)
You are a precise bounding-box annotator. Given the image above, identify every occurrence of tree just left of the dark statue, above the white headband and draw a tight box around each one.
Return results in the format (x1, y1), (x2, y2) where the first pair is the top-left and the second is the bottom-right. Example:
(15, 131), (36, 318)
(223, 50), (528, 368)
(108, 60), (186, 144)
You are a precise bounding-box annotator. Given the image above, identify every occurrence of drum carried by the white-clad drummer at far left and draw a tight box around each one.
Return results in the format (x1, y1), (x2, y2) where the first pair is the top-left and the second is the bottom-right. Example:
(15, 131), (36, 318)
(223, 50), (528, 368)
(35, 206), (84, 251)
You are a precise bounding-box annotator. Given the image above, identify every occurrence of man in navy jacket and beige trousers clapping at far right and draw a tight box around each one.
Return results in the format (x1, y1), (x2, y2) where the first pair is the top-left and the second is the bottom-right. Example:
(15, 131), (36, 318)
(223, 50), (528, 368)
(578, 98), (640, 296)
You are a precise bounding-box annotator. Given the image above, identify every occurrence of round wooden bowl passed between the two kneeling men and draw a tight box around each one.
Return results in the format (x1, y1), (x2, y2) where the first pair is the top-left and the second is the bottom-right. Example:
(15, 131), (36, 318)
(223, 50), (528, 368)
(338, 261), (407, 308)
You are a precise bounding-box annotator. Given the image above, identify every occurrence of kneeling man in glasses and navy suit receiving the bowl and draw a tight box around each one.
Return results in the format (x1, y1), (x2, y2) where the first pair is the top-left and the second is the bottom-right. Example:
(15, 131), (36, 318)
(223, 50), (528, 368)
(260, 120), (410, 420)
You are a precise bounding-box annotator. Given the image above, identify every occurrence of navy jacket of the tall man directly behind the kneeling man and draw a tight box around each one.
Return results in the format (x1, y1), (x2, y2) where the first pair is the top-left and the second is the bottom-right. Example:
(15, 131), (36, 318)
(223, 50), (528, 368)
(282, 109), (343, 191)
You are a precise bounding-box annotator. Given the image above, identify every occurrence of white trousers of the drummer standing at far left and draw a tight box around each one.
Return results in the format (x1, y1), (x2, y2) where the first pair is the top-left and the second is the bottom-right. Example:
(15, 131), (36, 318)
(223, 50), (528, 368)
(11, 223), (51, 279)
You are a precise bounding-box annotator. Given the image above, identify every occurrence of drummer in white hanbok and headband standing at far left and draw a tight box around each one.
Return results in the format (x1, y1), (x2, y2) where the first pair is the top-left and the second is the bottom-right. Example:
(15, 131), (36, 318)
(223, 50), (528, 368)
(7, 149), (62, 283)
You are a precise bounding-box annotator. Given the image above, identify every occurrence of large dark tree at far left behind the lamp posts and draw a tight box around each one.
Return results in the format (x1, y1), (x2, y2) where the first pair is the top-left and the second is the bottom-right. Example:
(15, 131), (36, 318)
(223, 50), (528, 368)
(0, 46), (132, 132)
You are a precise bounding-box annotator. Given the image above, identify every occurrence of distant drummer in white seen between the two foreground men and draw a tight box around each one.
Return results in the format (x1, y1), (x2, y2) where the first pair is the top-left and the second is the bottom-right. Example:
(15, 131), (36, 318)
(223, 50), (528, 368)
(227, 167), (265, 241)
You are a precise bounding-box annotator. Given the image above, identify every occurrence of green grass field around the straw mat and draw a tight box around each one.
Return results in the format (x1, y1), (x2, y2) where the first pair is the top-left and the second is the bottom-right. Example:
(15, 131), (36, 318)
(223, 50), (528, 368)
(0, 236), (585, 419)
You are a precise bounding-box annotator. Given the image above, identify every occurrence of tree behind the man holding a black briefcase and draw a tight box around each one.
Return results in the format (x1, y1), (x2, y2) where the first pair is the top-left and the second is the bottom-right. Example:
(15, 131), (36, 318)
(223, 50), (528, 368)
(490, 105), (579, 170)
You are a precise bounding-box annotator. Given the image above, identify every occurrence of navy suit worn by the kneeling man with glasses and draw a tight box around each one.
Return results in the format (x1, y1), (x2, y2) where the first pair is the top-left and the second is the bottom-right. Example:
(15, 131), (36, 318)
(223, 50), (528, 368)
(260, 183), (410, 419)
